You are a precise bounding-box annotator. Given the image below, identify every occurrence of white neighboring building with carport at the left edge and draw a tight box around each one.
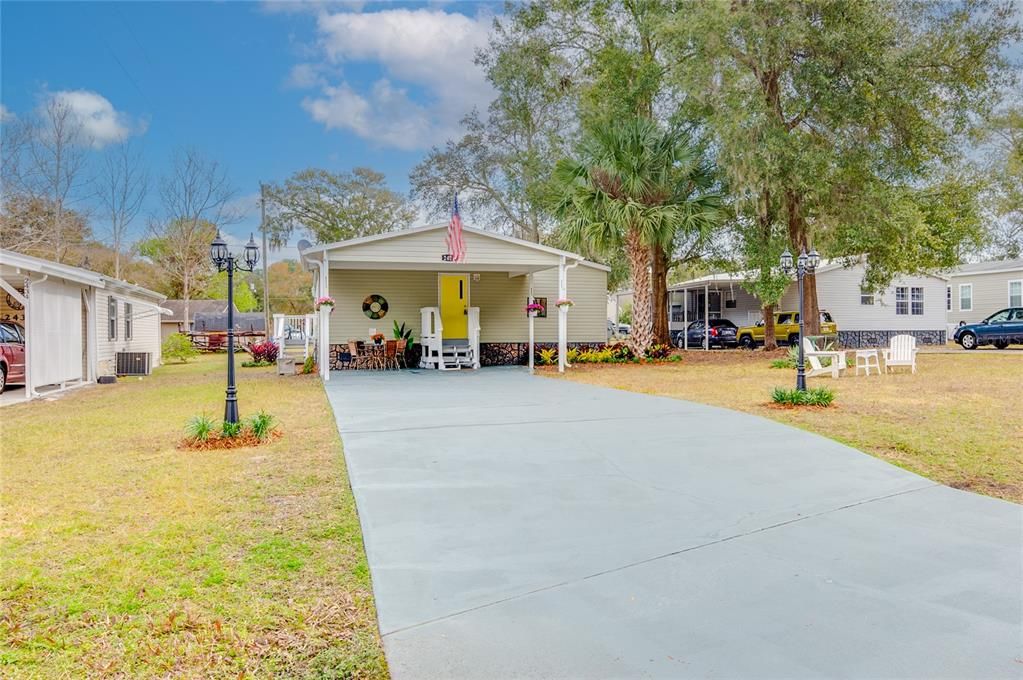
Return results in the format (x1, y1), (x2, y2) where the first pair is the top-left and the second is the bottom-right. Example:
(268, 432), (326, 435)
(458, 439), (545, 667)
(0, 250), (164, 398)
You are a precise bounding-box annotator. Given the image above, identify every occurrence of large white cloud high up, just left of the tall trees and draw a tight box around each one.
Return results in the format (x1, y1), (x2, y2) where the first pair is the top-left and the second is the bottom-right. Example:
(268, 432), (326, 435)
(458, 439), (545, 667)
(293, 8), (491, 149)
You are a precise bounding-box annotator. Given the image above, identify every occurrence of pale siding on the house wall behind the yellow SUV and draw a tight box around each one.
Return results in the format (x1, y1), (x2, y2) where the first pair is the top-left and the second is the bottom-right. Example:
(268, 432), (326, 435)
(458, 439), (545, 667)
(779, 265), (945, 330)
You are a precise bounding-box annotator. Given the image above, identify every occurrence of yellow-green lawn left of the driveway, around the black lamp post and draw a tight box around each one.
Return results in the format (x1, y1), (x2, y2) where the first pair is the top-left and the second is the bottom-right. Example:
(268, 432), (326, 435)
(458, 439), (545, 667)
(0, 355), (387, 678)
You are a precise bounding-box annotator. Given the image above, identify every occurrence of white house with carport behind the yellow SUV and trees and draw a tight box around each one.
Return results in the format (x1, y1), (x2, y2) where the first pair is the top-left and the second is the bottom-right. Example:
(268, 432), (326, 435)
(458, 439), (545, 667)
(618, 262), (946, 347)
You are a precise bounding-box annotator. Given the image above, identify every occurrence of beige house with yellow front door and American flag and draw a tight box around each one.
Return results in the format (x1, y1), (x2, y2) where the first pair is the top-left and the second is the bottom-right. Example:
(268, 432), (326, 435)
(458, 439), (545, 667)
(300, 224), (610, 368)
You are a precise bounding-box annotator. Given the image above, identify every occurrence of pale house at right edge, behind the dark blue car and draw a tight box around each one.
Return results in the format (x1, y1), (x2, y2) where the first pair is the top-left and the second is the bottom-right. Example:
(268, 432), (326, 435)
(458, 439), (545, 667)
(945, 260), (1023, 328)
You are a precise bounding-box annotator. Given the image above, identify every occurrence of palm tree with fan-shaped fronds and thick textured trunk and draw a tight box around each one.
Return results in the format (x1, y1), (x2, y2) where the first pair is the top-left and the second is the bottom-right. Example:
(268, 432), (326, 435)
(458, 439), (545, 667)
(551, 117), (723, 355)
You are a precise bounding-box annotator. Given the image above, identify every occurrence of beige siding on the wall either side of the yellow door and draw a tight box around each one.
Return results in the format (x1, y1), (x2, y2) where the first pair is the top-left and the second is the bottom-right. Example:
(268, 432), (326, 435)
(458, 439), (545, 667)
(330, 265), (607, 344)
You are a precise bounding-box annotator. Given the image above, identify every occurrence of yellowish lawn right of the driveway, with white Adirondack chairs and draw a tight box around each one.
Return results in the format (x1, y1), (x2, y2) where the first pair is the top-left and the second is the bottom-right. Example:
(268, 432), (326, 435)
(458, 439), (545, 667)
(544, 350), (1023, 503)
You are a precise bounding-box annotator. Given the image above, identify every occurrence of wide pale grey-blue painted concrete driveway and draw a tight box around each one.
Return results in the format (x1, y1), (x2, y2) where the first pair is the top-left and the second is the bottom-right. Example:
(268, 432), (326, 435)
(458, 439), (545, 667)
(326, 368), (1023, 679)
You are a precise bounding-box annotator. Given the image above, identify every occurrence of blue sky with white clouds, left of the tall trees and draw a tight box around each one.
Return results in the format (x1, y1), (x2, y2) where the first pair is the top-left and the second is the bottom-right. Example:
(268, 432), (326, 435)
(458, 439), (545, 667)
(0, 2), (500, 257)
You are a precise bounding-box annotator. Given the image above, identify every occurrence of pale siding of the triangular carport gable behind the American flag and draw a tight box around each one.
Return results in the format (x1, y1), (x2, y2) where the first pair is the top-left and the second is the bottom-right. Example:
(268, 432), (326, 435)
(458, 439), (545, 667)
(330, 229), (559, 271)
